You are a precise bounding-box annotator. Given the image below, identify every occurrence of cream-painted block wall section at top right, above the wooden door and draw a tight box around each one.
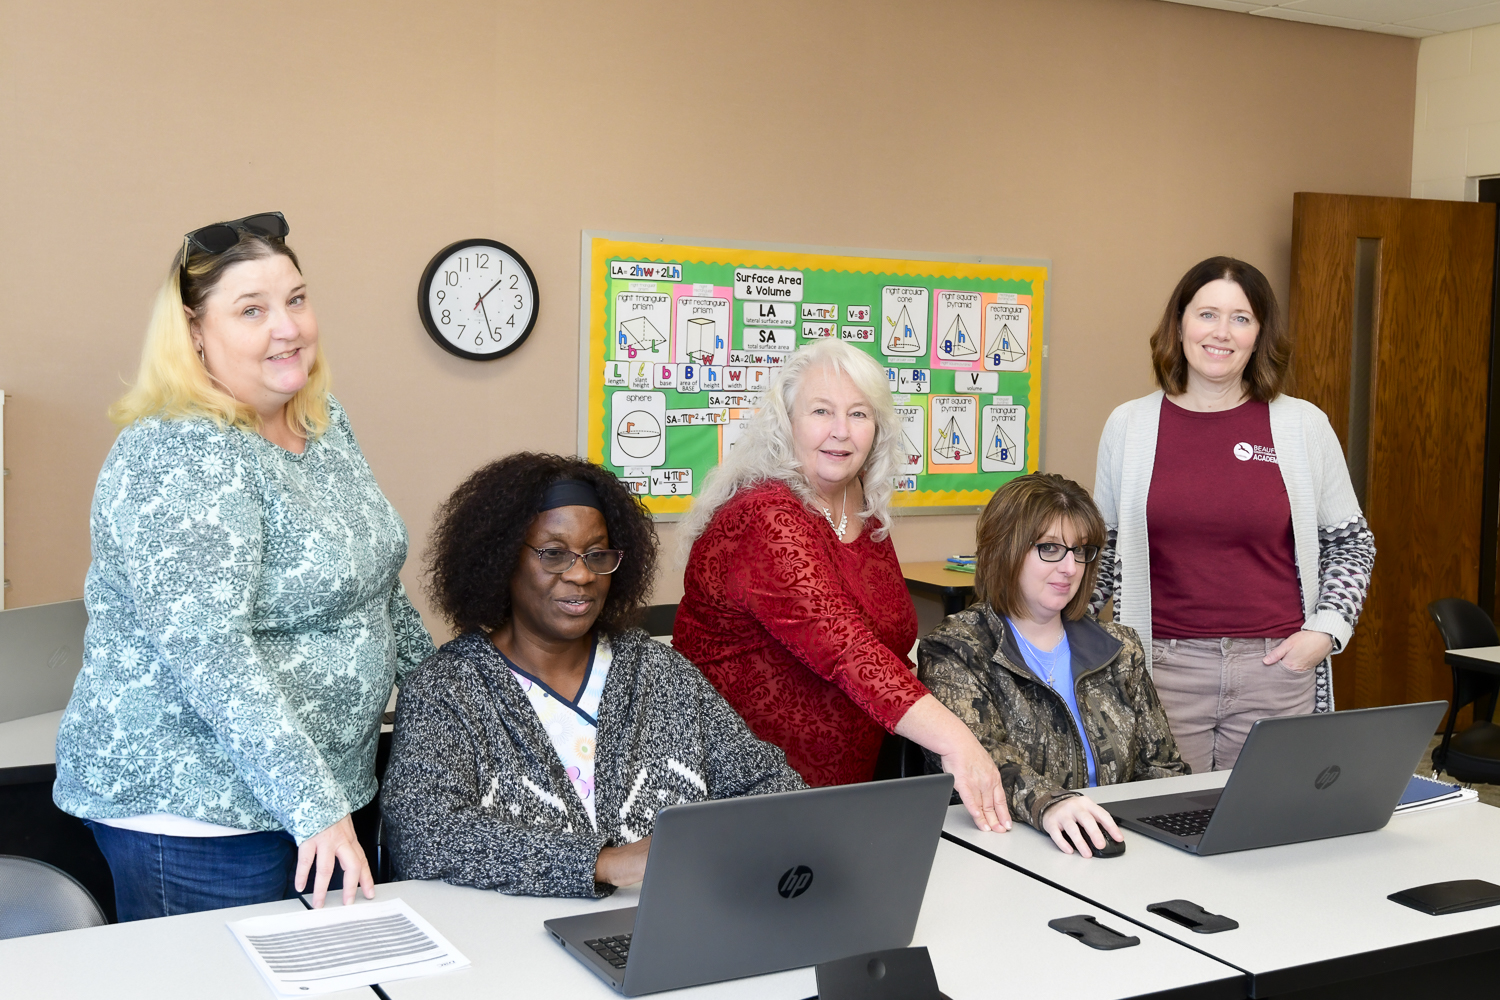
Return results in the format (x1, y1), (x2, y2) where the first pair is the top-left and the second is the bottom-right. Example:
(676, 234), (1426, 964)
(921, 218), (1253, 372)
(1412, 24), (1500, 201)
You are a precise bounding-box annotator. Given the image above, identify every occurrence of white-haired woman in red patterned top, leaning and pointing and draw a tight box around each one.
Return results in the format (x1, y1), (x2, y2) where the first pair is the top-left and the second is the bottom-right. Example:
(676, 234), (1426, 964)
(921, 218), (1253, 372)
(672, 340), (1010, 829)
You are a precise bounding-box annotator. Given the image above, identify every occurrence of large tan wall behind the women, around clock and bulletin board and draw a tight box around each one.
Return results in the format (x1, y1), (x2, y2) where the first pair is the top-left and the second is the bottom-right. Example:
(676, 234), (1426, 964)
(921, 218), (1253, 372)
(0, 0), (1416, 638)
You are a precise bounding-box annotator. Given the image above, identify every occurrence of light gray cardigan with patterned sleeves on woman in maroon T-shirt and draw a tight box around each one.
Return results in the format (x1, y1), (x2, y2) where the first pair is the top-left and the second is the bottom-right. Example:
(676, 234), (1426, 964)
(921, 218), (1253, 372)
(1089, 390), (1376, 712)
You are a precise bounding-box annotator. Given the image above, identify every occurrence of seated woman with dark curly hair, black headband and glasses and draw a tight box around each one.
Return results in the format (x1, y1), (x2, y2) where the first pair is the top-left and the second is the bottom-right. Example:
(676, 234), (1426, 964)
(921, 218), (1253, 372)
(381, 453), (803, 897)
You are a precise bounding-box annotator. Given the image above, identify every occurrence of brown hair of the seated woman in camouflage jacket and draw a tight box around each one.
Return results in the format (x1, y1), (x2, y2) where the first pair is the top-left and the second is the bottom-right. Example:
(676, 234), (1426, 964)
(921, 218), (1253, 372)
(974, 472), (1104, 621)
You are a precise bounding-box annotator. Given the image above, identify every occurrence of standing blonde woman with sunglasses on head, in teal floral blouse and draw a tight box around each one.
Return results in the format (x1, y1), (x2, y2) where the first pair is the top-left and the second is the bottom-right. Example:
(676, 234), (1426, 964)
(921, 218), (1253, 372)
(53, 213), (434, 921)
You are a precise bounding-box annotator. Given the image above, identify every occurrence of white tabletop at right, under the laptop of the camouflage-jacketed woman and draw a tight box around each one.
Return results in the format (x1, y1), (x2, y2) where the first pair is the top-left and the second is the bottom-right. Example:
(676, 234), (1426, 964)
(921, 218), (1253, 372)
(945, 771), (1500, 997)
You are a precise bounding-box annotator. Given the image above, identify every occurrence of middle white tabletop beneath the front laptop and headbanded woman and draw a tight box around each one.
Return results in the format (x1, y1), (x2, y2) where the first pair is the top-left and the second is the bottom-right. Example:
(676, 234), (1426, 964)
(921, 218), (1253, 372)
(333, 841), (1245, 1000)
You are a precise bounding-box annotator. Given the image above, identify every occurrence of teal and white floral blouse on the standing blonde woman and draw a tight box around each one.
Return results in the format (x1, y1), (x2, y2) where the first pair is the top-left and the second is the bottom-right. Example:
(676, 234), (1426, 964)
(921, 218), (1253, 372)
(53, 399), (434, 844)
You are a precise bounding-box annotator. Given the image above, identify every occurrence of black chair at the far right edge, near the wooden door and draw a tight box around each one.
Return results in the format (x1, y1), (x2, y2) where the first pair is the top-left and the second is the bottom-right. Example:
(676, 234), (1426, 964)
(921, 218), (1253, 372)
(1427, 597), (1500, 784)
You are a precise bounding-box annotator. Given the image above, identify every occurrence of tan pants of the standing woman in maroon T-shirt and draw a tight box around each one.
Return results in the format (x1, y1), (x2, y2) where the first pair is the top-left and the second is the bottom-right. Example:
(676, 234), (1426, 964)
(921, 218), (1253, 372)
(1151, 639), (1314, 772)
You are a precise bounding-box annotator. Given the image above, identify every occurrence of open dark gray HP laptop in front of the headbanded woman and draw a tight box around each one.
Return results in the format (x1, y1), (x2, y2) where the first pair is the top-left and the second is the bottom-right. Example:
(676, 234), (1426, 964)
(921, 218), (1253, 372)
(545, 774), (953, 997)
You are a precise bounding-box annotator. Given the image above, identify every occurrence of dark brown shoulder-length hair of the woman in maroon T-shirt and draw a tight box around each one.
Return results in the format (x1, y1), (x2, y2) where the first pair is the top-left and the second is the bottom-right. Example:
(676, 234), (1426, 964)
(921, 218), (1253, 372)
(1151, 256), (1292, 403)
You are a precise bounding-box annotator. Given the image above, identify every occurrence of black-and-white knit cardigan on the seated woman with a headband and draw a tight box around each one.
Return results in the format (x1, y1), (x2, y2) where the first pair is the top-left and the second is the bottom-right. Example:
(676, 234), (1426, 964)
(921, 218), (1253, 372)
(381, 631), (806, 897)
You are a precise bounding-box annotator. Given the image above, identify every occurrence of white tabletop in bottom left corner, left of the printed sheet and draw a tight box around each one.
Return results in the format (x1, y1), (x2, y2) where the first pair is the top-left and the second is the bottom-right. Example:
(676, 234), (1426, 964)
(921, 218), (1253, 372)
(0, 900), (375, 1000)
